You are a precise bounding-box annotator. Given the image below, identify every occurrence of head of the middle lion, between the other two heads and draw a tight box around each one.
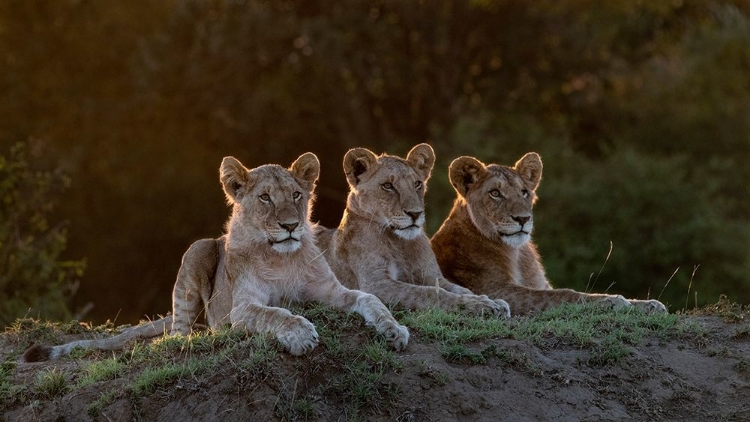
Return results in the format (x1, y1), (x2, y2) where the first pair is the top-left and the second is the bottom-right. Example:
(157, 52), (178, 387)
(344, 144), (435, 240)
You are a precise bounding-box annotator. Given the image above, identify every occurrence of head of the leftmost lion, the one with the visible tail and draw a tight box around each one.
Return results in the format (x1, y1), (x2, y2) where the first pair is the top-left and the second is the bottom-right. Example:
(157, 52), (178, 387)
(219, 152), (320, 252)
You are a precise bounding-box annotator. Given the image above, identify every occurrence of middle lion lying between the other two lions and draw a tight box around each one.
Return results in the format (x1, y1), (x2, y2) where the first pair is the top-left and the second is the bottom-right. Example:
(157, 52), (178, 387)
(316, 144), (510, 316)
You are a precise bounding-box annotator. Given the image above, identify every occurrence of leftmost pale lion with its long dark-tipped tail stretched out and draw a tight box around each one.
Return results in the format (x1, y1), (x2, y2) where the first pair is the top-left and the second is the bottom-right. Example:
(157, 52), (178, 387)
(24, 153), (409, 361)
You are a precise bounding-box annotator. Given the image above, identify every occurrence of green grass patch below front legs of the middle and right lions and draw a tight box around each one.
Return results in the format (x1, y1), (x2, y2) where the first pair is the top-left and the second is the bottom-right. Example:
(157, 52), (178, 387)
(401, 304), (705, 368)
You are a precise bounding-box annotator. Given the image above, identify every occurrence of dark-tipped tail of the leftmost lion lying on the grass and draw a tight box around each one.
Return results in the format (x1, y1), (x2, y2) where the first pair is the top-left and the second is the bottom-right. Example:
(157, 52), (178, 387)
(20, 315), (172, 362)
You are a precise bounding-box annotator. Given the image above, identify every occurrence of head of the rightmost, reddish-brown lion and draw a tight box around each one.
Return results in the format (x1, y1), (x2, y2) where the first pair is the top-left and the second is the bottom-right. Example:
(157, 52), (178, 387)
(448, 152), (542, 247)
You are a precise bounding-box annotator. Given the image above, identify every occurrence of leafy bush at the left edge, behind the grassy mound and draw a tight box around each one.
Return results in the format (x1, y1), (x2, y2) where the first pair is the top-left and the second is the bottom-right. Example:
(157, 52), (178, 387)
(0, 143), (84, 326)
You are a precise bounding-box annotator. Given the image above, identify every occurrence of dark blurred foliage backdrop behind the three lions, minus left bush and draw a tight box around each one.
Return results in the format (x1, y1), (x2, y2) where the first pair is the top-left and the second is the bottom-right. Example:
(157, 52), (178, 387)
(0, 0), (750, 323)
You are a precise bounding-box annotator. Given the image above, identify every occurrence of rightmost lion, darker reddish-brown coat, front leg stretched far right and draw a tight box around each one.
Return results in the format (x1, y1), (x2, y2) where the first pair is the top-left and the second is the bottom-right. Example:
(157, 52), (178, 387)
(431, 152), (666, 314)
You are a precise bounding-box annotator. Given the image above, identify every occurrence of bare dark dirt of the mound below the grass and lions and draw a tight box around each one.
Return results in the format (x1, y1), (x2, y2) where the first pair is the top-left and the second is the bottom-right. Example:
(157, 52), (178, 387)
(0, 316), (750, 422)
